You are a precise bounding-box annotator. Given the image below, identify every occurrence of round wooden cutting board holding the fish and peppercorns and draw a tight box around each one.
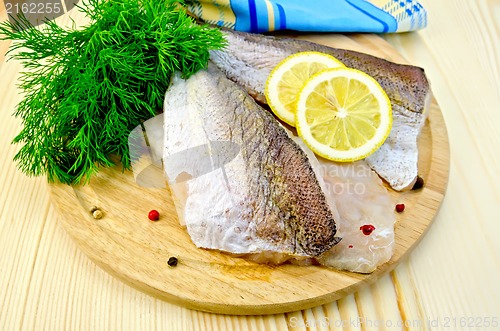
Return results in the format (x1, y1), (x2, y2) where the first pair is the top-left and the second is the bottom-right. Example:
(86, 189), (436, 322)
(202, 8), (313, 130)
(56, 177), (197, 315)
(50, 35), (449, 314)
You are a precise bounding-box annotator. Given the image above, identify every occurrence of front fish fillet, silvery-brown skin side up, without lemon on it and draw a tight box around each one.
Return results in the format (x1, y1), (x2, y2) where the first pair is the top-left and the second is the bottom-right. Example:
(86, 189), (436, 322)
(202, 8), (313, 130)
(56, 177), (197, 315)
(163, 65), (339, 257)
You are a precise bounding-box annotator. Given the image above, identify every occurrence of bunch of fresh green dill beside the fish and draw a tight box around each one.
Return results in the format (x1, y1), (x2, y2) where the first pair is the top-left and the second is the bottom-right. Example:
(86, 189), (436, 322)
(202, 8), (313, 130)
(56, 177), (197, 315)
(0, 0), (225, 184)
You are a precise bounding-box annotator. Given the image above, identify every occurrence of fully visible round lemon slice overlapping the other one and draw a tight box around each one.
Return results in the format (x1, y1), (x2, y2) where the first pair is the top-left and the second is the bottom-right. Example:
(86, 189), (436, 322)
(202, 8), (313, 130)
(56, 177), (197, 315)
(295, 68), (392, 162)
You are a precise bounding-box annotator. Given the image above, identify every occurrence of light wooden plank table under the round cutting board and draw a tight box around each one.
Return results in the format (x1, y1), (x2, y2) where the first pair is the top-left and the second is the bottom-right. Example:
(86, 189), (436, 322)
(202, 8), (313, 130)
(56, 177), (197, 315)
(0, 0), (500, 330)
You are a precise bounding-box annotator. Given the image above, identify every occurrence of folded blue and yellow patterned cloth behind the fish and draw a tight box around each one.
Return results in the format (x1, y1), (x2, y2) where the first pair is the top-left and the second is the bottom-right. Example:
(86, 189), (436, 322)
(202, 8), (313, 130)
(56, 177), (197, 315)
(185, 0), (427, 33)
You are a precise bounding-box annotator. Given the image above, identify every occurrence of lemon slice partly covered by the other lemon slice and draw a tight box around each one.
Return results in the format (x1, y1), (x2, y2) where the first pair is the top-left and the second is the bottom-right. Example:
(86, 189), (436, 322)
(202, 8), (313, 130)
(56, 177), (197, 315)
(264, 52), (344, 126)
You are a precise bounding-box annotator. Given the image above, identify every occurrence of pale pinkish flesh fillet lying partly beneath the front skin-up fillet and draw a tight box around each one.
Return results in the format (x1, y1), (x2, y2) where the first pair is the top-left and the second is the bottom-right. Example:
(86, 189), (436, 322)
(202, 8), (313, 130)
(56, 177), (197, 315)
(290, 133), (396, 273)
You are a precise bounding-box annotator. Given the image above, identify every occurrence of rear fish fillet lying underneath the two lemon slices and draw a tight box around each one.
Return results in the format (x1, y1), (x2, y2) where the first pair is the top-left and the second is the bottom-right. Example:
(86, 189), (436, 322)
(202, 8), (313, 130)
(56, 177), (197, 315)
(211, 30), (431, 191)
